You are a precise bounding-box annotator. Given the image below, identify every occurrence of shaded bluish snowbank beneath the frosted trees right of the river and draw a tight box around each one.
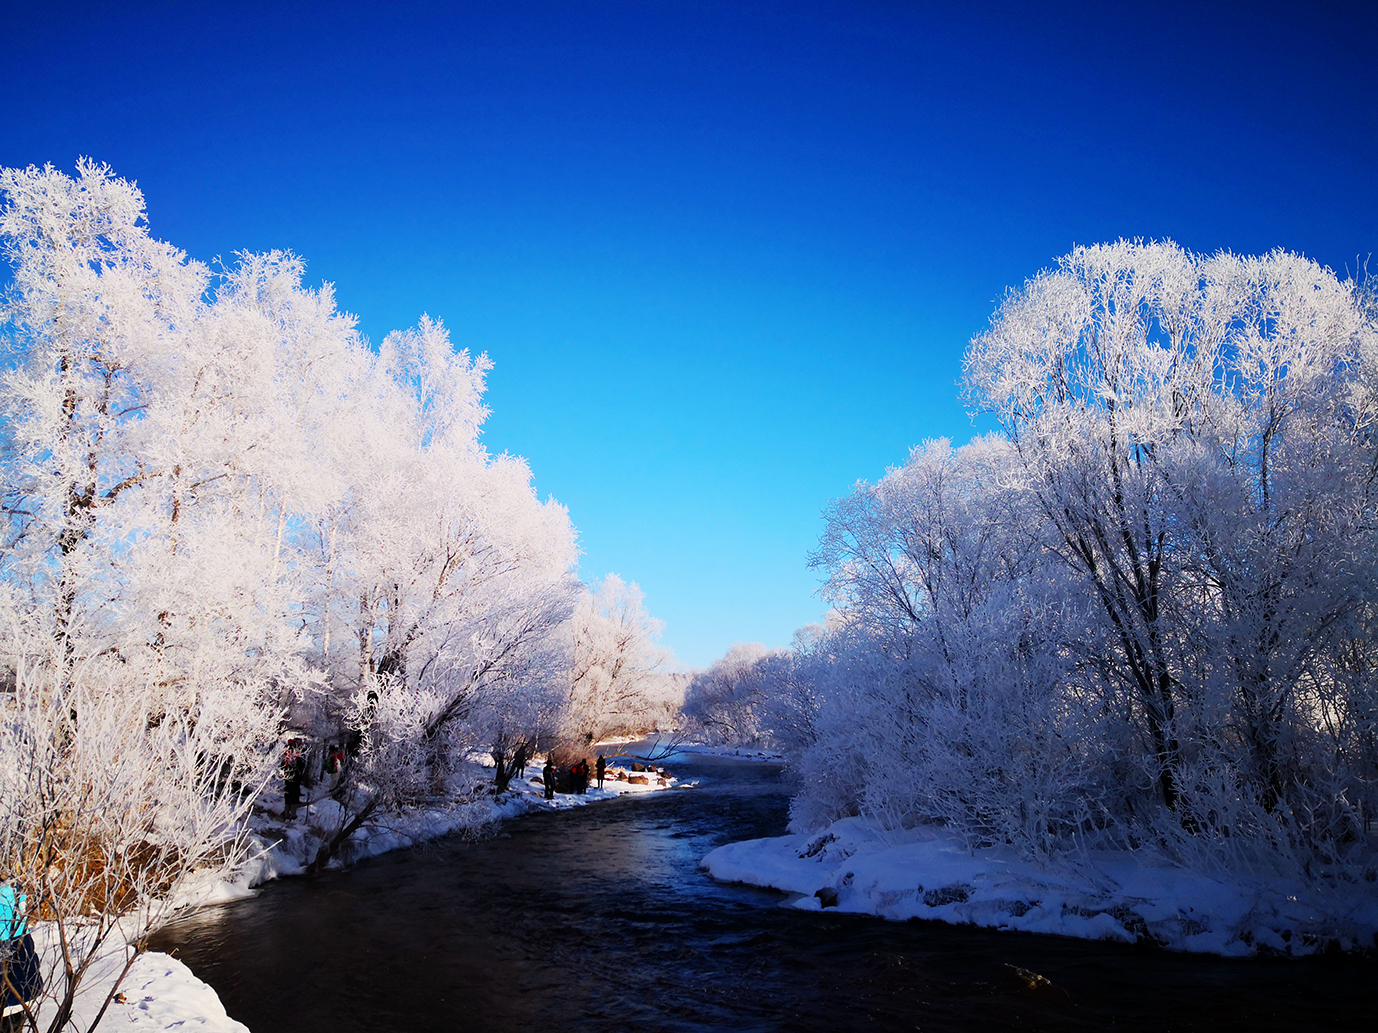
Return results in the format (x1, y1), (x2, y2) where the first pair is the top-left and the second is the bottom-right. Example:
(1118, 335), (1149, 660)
(701, 818), (1378, 956)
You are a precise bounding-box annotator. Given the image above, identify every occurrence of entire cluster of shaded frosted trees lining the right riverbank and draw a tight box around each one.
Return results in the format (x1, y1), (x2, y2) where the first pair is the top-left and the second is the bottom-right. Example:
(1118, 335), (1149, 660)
(766, 241), (1378, 872)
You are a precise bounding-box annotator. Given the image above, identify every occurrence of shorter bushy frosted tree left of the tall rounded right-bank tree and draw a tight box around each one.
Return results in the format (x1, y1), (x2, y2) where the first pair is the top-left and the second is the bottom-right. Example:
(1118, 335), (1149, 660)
(796, 438), (1102, 848)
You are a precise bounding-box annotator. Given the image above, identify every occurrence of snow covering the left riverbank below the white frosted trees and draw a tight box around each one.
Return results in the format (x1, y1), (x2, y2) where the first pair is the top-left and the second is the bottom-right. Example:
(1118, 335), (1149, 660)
(24, 763), (681, 1033)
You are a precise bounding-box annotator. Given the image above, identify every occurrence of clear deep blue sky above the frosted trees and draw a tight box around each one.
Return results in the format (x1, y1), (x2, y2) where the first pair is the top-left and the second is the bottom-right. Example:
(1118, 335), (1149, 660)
(0, 0), (1378, 664)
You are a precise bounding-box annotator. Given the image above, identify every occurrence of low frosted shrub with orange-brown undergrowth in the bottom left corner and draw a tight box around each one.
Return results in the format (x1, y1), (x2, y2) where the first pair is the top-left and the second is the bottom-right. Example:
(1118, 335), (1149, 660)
(0, 592), (277, 1033)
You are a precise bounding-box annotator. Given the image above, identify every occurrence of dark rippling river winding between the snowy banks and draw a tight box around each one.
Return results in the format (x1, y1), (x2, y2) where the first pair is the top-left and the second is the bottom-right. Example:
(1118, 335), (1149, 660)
(154, 758), (1378, 1033)
